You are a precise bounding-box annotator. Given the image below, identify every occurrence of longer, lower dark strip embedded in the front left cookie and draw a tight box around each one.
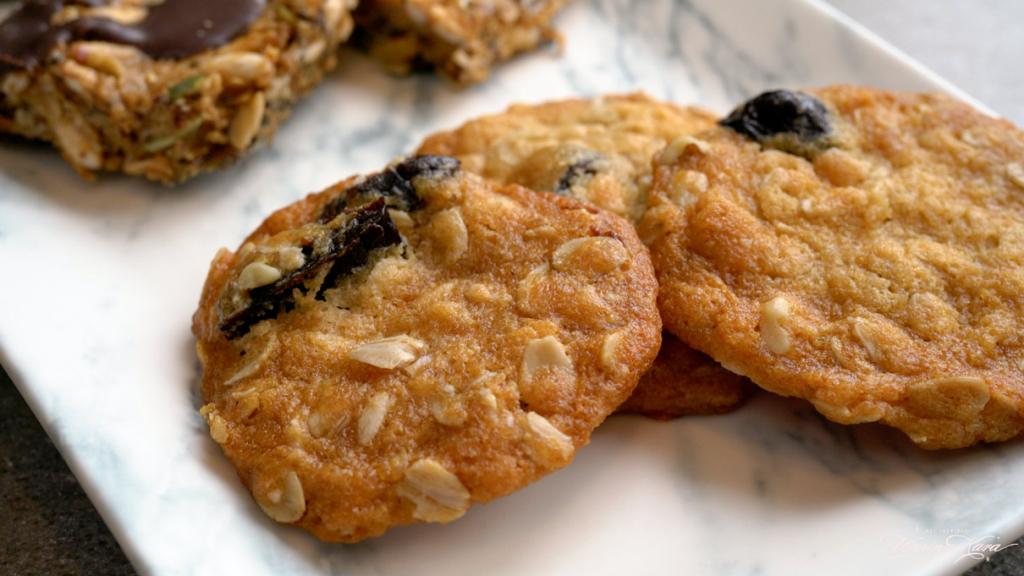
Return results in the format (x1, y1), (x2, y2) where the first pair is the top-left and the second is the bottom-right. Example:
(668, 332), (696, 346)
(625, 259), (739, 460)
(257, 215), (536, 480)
(220, 198), (401, 340)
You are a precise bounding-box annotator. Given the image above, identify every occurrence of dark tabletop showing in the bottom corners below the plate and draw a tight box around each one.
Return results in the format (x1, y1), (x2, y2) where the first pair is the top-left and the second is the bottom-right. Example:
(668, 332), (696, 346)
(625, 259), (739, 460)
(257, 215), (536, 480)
(0, 362), (1024, 576)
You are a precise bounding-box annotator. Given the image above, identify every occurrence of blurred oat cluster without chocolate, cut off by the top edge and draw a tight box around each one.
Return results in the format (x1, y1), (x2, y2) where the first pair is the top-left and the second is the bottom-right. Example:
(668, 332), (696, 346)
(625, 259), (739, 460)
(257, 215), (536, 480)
(355, 0), (568, 84)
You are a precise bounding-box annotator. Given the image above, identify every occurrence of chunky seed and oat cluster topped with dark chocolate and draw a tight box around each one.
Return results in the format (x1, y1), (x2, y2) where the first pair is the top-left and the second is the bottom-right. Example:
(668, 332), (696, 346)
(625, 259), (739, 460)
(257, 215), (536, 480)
(0, 0), (352, 183)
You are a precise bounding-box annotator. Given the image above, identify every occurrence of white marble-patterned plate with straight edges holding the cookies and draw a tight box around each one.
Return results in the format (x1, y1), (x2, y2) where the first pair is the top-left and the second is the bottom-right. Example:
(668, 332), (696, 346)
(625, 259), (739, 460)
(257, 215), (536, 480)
(0, 0), (1024, 575)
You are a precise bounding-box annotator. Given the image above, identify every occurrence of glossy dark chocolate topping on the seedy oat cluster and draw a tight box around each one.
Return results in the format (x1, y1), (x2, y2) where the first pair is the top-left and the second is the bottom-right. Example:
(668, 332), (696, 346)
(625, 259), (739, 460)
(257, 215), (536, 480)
(0, 0), (266, 71)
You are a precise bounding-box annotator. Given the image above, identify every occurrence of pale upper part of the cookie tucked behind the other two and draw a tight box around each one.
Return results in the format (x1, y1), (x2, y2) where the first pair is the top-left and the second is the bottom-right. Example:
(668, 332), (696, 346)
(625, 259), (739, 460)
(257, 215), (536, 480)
(418, 93), (716, 219)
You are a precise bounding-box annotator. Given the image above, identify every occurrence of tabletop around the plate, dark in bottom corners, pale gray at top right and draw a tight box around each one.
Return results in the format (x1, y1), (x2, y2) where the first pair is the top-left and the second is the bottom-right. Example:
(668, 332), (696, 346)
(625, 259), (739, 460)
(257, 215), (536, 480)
(0, 0), (1024, 575)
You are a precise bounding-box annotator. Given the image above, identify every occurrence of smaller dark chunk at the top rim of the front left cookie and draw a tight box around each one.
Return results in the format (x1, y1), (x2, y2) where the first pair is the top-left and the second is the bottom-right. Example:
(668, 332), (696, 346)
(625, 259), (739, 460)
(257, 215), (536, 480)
(318, 156), (460, 223)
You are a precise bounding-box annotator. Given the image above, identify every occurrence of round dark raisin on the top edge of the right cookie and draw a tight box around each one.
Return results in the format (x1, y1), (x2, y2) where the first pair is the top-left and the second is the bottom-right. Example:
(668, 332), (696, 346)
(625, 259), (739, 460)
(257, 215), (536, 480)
(720, 90), (831, 154)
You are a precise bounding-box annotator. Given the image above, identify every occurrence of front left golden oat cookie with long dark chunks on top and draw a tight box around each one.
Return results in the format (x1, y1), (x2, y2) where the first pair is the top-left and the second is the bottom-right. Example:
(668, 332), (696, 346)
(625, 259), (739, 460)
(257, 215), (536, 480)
(193, 156), (660, 542)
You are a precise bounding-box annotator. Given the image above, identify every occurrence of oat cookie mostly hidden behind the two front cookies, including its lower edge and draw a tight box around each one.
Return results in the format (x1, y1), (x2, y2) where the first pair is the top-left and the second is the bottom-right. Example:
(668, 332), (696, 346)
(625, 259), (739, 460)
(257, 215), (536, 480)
(419, 93), (746, 418)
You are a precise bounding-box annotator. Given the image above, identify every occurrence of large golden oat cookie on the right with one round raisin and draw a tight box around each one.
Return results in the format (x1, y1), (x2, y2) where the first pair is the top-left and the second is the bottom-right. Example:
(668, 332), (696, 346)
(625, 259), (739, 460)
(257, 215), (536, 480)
(641, 86), (1024, 449)
